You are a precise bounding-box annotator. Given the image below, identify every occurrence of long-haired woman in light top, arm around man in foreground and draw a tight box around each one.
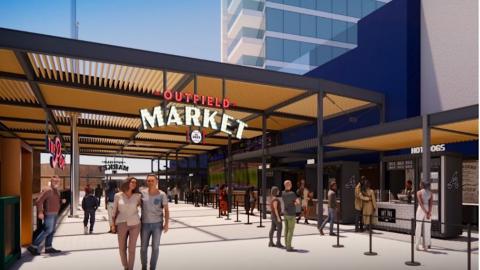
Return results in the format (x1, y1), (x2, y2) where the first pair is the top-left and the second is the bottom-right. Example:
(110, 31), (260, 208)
(112, 177), (142, 270)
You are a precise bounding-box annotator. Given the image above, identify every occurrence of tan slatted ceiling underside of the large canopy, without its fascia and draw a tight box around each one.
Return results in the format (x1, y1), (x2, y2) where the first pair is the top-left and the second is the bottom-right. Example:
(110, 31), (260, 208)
(0, 49), (378, 157)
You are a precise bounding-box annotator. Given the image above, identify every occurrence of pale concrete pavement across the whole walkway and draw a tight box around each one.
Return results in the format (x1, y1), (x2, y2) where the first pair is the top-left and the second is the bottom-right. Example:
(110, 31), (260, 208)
(12, 202), (478, 270)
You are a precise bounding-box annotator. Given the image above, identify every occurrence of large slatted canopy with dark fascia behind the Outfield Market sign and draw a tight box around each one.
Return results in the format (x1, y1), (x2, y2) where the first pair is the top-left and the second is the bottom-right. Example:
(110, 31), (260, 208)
(0, 28), (384, 159)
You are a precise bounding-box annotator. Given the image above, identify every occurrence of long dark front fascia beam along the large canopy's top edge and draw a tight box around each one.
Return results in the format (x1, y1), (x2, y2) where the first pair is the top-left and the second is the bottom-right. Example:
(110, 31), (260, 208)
(0, 28), (383, 103)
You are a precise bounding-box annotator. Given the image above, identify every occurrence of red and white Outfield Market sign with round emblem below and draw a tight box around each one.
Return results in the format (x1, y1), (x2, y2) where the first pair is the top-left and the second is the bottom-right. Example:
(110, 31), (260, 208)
(140, 91), (248, 143)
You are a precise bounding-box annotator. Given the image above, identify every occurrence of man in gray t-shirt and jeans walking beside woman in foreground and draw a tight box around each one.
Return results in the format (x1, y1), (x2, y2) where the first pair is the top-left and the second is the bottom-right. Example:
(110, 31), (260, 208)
(140, 174), (170, 270)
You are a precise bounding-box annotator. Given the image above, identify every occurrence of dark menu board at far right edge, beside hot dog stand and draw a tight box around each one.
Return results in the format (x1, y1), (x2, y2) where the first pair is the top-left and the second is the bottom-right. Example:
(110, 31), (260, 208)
(462, 160), (478, 204)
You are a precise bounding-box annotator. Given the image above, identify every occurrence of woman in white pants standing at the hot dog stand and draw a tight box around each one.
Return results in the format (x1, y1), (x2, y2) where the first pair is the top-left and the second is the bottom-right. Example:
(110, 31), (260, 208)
(415, 182), (433, 251)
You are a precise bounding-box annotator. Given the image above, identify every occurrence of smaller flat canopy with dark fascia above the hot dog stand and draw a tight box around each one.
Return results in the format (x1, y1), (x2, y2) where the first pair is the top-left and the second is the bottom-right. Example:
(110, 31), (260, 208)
(233, 104), (478, 161)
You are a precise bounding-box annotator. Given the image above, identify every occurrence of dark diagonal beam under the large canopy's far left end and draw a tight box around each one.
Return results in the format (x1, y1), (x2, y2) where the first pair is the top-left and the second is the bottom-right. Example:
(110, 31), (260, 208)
(14, 50), (65, 144)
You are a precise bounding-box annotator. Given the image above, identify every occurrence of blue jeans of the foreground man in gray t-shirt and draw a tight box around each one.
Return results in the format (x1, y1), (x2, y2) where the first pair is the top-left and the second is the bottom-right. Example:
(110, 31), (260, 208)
(140, 222), (163, 270)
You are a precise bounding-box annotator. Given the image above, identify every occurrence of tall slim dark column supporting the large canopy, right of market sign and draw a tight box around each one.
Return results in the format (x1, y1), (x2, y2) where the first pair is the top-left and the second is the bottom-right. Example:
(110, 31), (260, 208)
(315, 90), (325, 229)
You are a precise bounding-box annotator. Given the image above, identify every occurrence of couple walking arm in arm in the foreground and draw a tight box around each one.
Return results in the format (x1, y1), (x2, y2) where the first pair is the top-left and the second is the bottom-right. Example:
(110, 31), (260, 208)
(112, 175), (169, 270)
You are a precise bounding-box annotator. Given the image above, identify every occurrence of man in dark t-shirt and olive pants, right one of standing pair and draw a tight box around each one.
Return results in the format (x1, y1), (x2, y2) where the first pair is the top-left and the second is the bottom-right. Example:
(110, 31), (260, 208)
(282, 180), (300, 252)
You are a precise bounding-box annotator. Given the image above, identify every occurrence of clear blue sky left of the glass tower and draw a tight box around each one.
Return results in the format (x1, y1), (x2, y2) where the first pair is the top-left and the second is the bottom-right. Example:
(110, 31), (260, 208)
(0, 0), (220, 61)
